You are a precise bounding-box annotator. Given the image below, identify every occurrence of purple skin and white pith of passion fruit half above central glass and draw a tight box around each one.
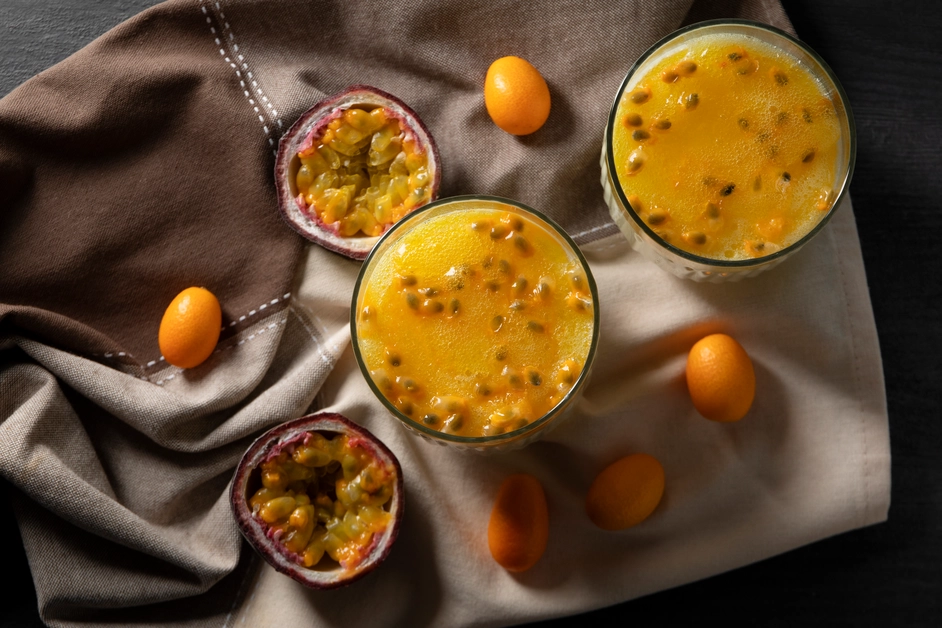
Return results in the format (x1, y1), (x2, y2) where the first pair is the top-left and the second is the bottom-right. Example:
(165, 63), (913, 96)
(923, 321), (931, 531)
(275, 85), (442, 260)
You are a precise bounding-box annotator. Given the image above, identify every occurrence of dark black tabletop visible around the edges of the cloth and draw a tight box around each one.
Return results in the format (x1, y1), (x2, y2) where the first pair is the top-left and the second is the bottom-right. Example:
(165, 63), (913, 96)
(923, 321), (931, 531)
(0, 0), (942, 627)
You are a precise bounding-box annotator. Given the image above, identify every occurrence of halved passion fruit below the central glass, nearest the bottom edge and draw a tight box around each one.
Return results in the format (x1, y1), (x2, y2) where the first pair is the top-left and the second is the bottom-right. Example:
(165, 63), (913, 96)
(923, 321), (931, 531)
(229, 413), (403, 589)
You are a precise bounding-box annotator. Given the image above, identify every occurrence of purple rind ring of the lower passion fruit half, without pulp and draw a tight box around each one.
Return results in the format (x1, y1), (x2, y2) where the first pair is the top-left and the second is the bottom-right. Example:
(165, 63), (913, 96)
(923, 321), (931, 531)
(229, 412), (405, 589)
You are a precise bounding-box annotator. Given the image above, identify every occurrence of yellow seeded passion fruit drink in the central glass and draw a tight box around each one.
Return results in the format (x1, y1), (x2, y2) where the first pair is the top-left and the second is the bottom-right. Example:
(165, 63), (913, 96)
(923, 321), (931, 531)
(355, 205), (596, 437)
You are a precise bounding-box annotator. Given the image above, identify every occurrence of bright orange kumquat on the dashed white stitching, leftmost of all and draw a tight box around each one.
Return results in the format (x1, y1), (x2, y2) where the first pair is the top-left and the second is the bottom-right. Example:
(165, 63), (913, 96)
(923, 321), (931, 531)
(158, 288), (222, 369)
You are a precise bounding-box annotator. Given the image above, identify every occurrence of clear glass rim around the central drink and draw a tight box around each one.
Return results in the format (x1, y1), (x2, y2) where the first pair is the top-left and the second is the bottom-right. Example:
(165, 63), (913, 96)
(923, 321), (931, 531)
(350, 194), (600, 445)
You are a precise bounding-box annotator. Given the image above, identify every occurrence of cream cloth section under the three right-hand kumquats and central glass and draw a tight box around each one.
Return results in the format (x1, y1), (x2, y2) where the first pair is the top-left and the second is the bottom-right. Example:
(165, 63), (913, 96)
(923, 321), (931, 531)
(228, 194), (890, 626)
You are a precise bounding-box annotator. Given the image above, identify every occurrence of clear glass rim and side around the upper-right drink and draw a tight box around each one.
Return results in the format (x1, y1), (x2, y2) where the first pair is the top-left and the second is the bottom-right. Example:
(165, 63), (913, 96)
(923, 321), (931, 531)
(605, 19), (857, 269)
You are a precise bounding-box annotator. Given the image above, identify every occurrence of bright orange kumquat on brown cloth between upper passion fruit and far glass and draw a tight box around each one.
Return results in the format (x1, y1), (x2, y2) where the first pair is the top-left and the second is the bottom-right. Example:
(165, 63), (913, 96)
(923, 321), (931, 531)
(484, 57), (550, 135)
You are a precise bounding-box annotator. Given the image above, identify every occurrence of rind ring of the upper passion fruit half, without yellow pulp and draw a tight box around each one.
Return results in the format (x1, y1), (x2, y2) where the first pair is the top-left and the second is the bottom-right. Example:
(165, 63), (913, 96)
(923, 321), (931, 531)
(275, 85), (441, 260)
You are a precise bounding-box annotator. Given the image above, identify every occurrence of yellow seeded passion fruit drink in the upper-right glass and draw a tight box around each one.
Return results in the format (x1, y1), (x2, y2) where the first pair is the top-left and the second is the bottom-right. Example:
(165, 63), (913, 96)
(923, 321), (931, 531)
(612, 33), (844, 260)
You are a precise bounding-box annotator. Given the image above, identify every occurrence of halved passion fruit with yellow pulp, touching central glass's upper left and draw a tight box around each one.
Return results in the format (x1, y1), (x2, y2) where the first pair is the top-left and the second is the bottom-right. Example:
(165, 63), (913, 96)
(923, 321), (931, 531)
(275, 85), (441, 259)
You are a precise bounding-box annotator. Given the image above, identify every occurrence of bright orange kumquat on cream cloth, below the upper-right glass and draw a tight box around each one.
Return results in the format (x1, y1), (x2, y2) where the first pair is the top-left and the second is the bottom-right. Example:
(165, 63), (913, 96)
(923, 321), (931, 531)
(687, 334), (756, 422)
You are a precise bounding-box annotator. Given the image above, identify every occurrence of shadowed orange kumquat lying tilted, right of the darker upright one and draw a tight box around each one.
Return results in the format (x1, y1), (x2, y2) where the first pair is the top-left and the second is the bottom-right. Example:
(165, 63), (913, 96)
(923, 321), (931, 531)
(585, 454), (664, 530)
